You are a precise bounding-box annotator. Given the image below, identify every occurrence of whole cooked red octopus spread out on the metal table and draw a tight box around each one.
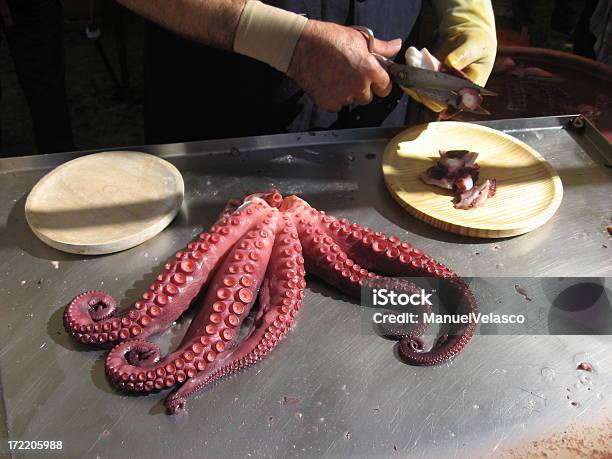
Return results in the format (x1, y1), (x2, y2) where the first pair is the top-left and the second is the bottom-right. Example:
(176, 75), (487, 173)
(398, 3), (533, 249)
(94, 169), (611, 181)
(63, 190), (477, 413)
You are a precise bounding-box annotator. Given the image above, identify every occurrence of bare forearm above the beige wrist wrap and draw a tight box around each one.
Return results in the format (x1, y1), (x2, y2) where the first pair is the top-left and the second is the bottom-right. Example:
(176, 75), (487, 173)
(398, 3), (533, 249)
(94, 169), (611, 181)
(117, 0), (247, 49)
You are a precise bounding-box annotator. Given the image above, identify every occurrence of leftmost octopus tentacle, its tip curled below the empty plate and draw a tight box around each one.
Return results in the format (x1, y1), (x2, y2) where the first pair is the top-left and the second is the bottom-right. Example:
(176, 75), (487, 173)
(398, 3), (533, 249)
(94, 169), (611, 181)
(64, 198), (270, 346)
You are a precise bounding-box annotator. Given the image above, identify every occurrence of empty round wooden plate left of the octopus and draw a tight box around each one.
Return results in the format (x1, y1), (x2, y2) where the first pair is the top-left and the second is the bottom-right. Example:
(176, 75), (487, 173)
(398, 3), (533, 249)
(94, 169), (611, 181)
(25, 151), (185, 255)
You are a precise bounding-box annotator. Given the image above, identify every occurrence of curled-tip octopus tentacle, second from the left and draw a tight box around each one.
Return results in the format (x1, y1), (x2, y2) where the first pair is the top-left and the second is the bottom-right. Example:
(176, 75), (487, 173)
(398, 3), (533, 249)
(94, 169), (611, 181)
(106, 210), (280, 391)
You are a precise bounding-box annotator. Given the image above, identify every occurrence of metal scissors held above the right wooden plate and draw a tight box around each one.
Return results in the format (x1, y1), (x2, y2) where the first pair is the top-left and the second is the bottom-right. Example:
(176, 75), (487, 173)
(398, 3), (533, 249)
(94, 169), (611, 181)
(353, 26), (497, 115)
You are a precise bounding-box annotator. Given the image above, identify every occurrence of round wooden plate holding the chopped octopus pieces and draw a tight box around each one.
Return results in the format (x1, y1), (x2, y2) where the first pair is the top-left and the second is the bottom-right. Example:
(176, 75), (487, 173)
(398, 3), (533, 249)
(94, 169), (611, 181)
(383, 121), (563, 238)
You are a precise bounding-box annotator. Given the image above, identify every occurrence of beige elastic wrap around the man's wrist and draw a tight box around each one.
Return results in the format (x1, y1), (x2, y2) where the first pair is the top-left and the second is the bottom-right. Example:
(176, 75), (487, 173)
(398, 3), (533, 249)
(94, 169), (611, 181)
(234, 0), (308, 72)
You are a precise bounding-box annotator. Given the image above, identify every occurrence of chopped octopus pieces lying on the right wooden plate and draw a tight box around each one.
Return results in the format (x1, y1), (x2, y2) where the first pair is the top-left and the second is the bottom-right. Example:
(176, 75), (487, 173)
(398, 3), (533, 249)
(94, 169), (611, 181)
(420, 150), (497, 209)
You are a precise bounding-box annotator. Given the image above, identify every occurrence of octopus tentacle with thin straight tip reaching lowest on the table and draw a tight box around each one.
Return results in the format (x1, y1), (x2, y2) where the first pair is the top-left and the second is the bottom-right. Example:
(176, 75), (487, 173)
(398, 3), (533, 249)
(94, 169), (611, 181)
(166, 215), (306, 414)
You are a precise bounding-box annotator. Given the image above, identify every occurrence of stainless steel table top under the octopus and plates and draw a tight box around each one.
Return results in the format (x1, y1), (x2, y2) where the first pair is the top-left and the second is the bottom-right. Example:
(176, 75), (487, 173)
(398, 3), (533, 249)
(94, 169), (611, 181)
(0, 118), (612, 458)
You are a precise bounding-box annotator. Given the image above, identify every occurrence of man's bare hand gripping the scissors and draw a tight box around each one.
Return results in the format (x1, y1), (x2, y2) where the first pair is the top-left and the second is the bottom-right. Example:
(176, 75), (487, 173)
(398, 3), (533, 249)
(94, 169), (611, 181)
(287, 20), (402, 112)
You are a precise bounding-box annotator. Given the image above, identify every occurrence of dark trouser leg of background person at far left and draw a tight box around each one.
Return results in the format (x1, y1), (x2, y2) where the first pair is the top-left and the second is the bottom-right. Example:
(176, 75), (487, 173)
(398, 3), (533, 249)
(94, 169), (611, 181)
(0, 0), (75, 153)
